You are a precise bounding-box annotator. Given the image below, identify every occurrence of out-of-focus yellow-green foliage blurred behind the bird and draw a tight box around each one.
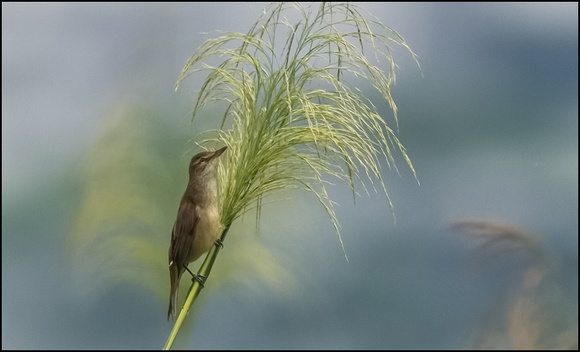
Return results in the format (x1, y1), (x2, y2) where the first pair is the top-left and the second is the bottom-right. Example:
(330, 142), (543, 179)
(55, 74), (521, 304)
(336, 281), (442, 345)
(65, 104), (295, 306)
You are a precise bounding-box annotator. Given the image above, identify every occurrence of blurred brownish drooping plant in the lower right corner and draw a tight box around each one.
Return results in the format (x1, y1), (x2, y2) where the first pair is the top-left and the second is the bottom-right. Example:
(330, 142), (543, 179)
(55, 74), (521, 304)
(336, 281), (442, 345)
(451, 221), (578, 349)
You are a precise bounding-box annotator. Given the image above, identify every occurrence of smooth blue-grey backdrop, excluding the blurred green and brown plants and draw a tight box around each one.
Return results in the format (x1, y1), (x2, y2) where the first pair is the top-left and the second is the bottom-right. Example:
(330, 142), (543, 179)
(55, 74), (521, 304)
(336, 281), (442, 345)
(2, 2), (578, 349)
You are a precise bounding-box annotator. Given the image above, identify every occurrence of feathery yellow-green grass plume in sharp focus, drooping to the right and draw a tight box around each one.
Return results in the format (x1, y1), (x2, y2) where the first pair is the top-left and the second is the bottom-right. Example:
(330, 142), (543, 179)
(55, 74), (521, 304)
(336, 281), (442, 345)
(165, 3), (415, 350)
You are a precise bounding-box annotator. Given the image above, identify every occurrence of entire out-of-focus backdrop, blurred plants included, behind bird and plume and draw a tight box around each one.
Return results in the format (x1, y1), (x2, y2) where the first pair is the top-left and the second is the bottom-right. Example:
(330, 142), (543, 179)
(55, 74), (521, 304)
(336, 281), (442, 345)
(2, 2), (578, 349)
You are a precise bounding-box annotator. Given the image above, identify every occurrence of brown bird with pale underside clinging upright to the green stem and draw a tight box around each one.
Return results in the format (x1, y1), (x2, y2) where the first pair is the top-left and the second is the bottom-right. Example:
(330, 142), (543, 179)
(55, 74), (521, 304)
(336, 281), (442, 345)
(167, 147), (227, 319)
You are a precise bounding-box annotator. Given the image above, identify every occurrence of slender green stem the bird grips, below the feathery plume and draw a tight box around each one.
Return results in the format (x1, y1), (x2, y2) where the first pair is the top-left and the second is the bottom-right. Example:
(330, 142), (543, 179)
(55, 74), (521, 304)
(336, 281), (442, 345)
(163, 225), (230, 350)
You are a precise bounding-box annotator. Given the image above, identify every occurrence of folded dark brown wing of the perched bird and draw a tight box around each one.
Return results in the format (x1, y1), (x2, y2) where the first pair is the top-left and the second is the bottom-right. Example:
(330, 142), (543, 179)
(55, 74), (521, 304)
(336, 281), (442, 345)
(169, 201), (199, 271)
